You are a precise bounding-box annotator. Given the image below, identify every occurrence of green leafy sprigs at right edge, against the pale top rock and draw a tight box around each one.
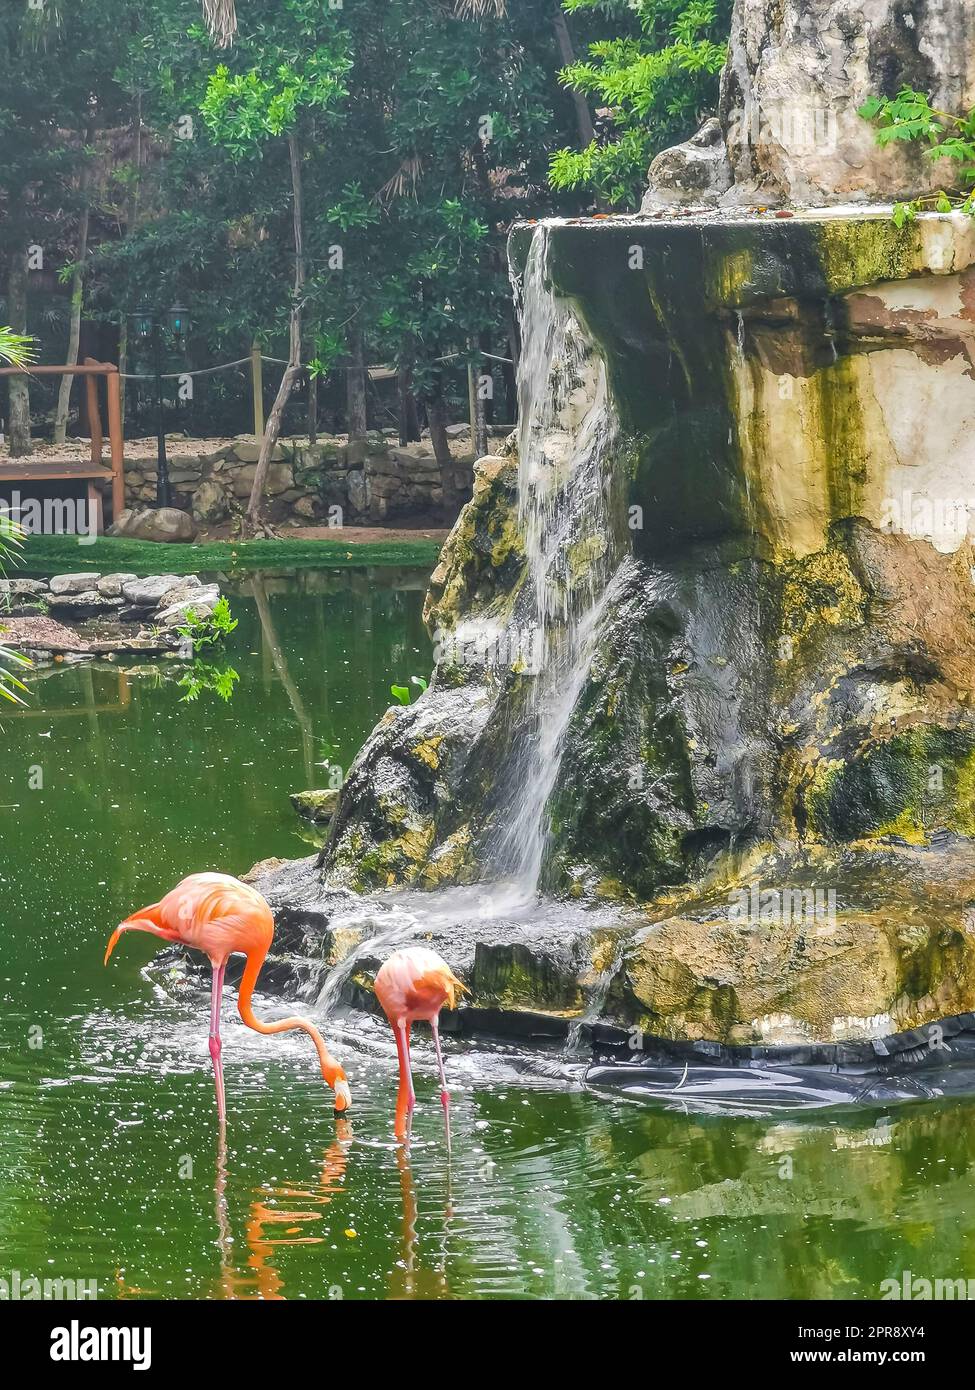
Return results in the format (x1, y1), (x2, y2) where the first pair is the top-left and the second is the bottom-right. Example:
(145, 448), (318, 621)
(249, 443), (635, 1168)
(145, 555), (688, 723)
(858, 86), (975, 227)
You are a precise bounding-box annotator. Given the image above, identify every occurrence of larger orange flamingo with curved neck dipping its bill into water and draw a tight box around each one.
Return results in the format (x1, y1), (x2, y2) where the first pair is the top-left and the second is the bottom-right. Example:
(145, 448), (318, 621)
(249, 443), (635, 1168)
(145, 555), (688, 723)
(104, 873), (352, 1125)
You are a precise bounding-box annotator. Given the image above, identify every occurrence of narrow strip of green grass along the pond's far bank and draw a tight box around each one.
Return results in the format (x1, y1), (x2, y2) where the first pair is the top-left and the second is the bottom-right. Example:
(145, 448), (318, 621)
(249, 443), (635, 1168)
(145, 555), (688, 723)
(21, 535), (441, 574)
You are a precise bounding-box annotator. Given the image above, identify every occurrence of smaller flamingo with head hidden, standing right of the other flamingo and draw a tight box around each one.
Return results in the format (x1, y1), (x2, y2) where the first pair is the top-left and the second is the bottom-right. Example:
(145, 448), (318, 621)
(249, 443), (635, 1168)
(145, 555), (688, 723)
(376, 947), (466, 1152)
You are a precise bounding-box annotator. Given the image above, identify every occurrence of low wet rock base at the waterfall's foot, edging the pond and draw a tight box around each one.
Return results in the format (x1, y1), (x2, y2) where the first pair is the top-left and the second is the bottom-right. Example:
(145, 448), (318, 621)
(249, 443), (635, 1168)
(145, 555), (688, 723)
(245, 841), (975, 1076)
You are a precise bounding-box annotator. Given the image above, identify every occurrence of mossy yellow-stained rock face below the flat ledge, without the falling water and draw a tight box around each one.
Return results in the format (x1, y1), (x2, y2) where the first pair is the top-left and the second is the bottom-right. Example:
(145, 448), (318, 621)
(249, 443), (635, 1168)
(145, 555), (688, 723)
(310, 205), (975, 1045)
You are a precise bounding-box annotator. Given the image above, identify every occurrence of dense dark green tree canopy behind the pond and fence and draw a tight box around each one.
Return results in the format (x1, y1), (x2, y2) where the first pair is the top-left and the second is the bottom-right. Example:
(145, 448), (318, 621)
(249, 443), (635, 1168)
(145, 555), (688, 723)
(0, 0), (730, 467)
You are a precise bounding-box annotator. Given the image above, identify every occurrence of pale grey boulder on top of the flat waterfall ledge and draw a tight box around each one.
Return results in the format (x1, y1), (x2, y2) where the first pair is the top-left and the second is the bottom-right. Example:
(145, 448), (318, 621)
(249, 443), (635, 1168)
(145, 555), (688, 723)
(644, 0), (975, 211)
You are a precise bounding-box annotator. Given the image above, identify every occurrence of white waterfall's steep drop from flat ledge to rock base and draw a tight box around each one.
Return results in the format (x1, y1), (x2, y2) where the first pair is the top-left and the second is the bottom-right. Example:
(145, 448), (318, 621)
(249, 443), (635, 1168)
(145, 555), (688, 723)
(488, 222), (622, 898)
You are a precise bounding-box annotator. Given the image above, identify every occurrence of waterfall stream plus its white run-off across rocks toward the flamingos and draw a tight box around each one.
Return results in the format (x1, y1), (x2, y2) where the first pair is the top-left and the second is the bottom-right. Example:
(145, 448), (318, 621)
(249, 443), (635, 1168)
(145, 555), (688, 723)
(317, 222), (631, 1017)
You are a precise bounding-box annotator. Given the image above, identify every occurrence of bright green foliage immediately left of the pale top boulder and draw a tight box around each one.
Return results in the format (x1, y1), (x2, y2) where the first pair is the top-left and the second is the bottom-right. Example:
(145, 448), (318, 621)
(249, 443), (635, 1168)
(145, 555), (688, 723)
(549, 0), (732, 206)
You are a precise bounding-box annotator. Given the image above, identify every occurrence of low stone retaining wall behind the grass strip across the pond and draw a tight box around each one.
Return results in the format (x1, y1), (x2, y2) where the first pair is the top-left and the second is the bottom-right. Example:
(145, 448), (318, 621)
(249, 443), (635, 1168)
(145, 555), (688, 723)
(125, 427), (473, 525)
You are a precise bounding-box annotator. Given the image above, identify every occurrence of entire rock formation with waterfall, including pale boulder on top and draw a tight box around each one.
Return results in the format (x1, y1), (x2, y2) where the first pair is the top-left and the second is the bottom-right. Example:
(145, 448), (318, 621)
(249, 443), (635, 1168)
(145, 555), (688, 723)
(257, 0), (975, 1065)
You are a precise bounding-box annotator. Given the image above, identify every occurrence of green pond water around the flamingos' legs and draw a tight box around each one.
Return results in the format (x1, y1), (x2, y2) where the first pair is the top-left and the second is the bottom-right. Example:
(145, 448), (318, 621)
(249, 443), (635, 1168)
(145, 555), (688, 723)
(0, 570), (975, 1300)
